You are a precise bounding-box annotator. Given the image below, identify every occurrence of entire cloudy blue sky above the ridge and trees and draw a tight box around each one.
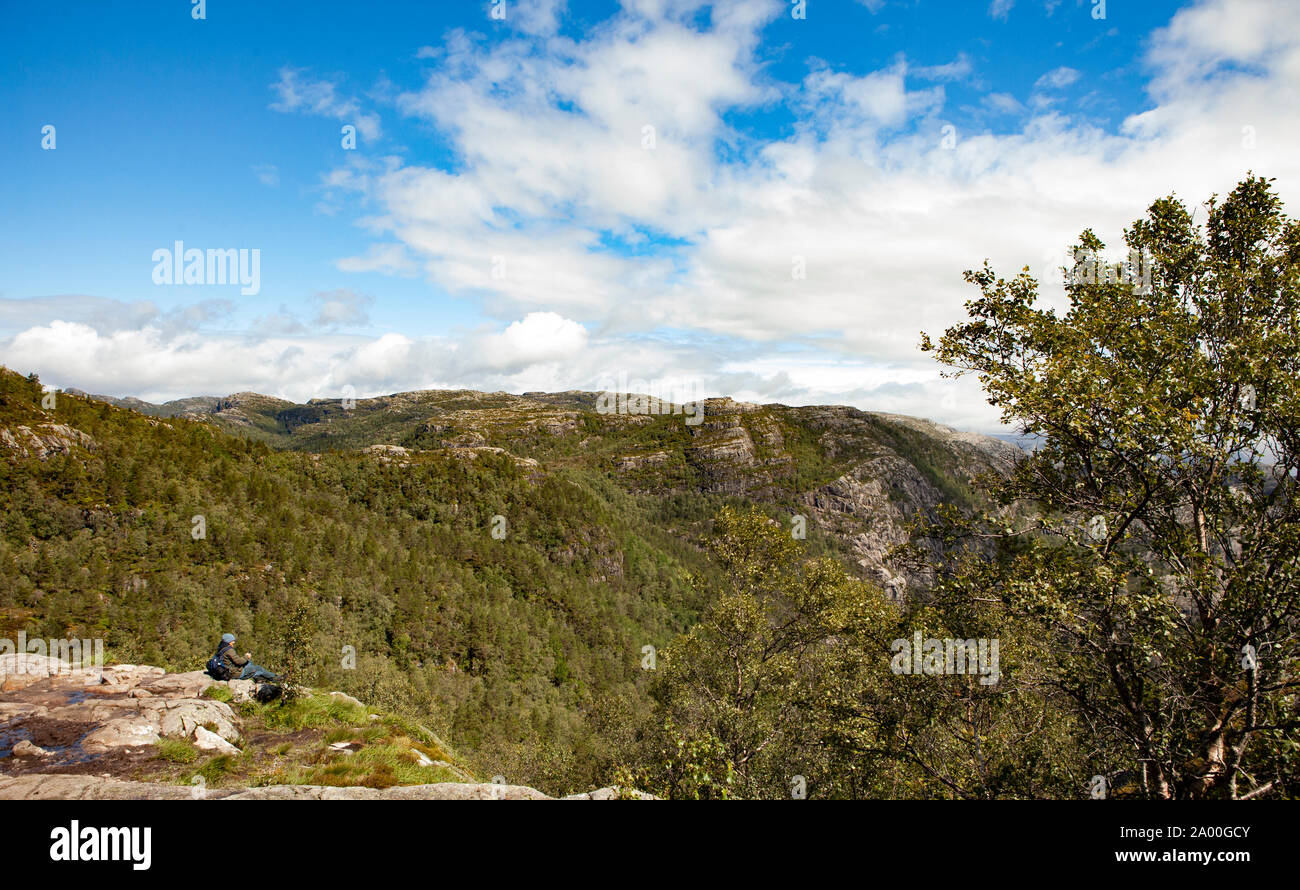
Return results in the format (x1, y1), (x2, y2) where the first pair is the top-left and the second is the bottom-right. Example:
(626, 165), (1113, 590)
(0, 0), (1300, 429)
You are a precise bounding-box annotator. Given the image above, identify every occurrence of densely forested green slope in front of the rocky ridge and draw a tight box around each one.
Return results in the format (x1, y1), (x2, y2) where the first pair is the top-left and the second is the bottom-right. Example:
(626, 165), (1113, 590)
(0, 372), (709, 780)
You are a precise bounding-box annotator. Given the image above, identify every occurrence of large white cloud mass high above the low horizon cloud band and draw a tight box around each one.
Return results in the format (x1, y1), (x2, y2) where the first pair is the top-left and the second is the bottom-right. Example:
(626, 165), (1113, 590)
(330, 0), (1300, 425)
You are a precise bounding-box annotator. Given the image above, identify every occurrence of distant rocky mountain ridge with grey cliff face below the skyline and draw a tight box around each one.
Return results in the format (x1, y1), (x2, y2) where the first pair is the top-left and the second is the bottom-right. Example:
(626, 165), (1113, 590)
(55, 379), (1024, 596)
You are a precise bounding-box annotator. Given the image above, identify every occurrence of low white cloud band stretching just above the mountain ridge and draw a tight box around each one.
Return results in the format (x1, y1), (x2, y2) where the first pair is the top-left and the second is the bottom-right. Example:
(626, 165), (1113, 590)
(3, 313), (987, 427)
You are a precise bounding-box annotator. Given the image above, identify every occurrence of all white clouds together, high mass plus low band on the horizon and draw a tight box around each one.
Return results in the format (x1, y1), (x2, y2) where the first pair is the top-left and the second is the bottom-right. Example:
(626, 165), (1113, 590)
(0, 0), (1300, 429)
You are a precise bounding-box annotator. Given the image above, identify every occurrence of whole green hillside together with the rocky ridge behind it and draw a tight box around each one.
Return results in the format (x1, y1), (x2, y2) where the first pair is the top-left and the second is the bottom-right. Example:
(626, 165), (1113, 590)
(0, 363), (1008, 791)
